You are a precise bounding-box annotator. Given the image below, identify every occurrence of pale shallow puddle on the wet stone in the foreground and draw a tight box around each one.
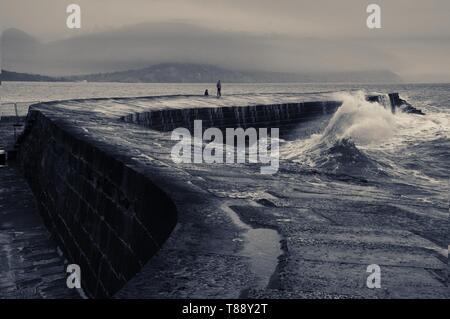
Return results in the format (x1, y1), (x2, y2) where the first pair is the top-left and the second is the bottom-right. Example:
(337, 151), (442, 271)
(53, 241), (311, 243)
(222, 204), (283, 288)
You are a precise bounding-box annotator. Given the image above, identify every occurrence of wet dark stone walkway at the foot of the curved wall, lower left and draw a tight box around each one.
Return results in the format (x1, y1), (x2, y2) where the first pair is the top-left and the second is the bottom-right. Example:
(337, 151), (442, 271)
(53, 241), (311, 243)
(0, 122), (79, 299)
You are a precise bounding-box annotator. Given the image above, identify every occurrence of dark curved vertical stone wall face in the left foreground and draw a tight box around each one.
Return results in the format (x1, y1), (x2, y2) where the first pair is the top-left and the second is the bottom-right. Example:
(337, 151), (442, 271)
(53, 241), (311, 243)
(18, 110), (177, 298)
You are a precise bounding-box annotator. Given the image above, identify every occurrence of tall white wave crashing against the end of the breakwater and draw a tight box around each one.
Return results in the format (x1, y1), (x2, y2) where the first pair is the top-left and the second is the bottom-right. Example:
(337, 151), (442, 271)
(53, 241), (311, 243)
(282, 92), (396, 176)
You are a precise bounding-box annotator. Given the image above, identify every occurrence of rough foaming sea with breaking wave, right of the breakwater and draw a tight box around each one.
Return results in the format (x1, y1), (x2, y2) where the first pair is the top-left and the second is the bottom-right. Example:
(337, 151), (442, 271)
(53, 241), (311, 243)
(281, 86), (450, 228)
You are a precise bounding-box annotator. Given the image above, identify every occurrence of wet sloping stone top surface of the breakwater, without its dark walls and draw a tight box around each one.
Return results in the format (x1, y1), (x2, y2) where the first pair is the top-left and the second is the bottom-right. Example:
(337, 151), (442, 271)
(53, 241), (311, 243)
(7, 96), (449, 298)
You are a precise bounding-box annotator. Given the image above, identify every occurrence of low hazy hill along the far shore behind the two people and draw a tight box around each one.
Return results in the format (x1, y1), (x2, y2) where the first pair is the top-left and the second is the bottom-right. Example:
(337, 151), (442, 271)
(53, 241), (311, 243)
(0, 63), (401, 83)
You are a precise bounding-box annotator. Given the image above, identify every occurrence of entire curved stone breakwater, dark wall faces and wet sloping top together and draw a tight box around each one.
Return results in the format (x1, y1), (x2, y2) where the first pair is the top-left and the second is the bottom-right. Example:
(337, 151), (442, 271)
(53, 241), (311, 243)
(10, 94), (442, 299)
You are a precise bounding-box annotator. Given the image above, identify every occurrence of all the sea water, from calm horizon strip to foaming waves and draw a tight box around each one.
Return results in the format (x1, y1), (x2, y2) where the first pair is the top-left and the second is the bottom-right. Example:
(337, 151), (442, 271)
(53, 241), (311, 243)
(1, 82), (450, 243)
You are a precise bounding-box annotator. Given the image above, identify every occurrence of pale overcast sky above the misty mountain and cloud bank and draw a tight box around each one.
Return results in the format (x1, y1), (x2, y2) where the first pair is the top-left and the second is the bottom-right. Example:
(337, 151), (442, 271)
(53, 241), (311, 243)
(1, 0), (450, 39)
